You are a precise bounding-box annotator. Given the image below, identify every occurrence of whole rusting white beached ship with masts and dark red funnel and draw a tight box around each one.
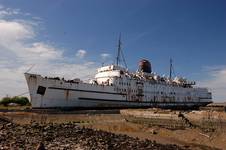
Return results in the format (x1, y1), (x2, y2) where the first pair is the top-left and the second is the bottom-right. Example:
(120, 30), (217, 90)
(25, 37), (212, 108)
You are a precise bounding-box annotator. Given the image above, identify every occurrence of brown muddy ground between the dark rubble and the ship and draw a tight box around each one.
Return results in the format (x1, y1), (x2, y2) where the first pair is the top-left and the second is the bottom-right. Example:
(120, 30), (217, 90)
(0, 112), (226, 150)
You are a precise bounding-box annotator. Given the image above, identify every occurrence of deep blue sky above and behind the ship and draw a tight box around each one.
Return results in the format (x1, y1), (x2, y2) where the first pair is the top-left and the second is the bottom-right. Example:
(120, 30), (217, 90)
(0, 0), (226, 100)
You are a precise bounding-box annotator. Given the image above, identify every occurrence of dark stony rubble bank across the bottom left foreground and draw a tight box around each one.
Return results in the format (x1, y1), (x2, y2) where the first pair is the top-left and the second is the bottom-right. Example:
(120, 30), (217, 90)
(0, 122), (188, 150)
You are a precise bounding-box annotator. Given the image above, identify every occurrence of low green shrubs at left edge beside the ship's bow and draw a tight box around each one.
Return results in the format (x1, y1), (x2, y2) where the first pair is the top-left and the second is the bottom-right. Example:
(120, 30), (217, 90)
(0, 96), (30, 106)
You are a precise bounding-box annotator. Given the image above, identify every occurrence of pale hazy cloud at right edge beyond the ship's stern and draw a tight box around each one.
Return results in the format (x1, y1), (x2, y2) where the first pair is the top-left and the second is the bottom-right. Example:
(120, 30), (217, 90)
(199, 66), (226, 101)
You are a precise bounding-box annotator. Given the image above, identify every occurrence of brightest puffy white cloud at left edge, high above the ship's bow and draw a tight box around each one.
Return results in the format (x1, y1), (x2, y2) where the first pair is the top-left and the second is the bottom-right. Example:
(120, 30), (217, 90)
(0, 19), (63, 64)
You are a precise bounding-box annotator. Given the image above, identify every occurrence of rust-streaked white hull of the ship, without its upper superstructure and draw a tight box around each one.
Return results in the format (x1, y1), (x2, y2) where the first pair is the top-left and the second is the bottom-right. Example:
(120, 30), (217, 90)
(25, 73), (211, 108)
